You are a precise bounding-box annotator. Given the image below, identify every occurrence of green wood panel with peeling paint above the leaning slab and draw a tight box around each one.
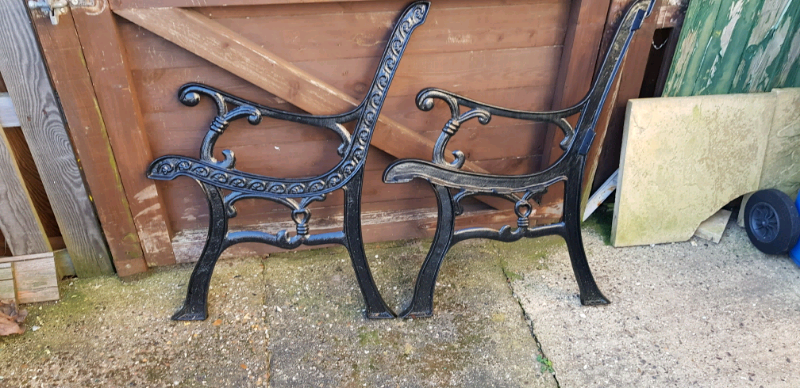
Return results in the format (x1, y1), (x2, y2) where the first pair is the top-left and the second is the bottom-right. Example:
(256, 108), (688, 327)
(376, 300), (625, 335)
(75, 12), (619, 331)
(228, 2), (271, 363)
(664, 0), (800, 96)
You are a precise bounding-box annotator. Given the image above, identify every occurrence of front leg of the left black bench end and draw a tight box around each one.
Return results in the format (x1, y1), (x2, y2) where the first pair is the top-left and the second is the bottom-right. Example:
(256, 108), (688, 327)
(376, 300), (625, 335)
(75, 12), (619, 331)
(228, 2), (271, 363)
(172, 181), (228, 321)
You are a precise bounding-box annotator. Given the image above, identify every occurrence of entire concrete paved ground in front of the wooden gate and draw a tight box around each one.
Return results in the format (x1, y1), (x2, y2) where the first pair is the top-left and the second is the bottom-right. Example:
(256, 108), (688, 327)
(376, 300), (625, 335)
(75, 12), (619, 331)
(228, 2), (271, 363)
(0, 217), (800, 387)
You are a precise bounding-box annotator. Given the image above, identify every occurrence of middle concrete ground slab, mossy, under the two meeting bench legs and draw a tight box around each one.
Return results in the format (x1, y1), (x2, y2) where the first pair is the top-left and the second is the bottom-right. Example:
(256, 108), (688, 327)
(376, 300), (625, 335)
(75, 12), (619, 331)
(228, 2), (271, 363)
(265, 242), (556, 387)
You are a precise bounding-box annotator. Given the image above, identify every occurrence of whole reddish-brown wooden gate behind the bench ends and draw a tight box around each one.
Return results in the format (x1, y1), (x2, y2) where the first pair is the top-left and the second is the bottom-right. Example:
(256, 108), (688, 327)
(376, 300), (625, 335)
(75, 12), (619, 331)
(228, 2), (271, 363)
(19, 0), (680, 275)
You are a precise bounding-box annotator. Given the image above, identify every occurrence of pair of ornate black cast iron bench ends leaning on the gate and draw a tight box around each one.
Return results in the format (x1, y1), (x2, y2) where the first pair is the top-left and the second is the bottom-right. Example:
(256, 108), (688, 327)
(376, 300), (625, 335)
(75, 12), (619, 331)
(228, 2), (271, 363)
(147, 0), (654, 320)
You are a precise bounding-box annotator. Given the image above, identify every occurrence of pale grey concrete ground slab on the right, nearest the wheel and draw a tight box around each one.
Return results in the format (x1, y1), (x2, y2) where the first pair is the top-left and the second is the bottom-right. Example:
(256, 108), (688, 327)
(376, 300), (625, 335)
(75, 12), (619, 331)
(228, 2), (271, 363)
(507, 222), (800, 388)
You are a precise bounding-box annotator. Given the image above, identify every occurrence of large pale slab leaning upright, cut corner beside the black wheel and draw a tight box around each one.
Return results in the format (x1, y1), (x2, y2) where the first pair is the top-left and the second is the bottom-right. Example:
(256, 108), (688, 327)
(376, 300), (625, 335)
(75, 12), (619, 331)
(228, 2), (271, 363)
(611, 93), (775, 247)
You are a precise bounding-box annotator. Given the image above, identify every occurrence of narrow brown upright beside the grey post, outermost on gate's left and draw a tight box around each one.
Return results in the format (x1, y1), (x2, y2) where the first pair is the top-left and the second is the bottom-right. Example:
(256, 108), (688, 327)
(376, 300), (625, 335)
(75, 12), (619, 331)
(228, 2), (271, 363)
(32, 9), (147, 277)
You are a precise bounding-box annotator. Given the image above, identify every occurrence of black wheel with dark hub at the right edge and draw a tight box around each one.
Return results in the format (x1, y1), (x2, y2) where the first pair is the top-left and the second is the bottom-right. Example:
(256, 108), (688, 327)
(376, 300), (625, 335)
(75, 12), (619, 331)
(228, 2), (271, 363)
(744, 189), (800, 255)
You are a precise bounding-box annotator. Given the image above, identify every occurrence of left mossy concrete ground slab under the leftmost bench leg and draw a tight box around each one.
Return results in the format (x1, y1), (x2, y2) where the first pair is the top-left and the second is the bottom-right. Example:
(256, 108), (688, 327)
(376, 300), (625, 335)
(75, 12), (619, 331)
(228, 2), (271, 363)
(0, 258), (269, 388)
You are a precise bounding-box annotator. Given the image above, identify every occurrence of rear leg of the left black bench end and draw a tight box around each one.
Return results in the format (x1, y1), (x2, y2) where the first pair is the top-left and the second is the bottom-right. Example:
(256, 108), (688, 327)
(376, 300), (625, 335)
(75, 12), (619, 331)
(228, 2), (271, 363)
(343, 168), (396, 319)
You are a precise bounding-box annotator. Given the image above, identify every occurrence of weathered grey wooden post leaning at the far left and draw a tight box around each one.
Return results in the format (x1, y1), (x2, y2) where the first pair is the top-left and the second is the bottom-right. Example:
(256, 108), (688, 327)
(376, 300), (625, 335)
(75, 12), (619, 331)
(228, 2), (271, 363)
(0, 1), (114, 276)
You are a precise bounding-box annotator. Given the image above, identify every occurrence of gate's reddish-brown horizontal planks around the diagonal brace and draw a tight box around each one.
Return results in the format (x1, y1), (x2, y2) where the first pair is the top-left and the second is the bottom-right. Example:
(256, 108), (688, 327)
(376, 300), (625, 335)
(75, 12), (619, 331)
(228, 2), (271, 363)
(115, 0), (570, 233)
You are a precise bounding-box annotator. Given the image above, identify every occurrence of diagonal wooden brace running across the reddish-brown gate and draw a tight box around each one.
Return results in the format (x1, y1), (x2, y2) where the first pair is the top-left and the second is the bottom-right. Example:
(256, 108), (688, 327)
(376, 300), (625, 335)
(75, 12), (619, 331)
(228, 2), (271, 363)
(118, 4), (510, 214)
